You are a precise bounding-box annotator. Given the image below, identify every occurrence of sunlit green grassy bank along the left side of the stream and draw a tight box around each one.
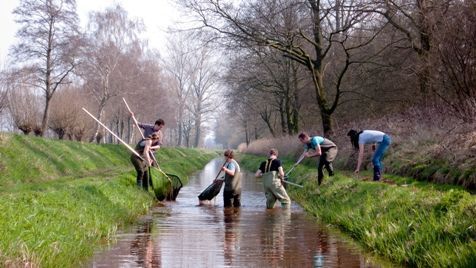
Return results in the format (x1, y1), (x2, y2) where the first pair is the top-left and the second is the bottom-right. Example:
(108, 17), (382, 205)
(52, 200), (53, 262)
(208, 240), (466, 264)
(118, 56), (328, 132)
(0, 133), (215, 267)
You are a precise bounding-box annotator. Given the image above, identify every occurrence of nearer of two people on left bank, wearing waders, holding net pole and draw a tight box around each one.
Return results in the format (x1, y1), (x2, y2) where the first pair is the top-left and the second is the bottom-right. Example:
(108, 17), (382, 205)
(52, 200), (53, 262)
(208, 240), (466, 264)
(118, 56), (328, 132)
(131, 133), (159, 191)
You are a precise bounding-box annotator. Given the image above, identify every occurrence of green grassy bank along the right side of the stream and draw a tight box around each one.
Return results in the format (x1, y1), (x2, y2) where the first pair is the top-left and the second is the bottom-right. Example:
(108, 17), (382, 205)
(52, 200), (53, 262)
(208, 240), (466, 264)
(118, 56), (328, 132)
(240, 155), (476, 267)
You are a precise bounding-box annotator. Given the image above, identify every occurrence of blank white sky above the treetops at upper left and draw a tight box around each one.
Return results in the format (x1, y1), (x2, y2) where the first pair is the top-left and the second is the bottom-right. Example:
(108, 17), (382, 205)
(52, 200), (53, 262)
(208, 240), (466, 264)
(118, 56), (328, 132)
(0, 0), (179, 63)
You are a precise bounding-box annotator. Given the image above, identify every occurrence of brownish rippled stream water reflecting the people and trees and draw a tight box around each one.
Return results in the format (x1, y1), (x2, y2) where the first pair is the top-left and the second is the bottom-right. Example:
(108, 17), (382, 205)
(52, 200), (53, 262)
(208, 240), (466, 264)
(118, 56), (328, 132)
(86, 159), (379, 268)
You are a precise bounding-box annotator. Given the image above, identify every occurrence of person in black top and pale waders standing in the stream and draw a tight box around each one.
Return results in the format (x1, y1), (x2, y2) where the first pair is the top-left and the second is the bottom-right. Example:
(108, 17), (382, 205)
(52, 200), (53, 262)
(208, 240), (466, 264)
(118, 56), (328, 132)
(255, 149), (291, 209)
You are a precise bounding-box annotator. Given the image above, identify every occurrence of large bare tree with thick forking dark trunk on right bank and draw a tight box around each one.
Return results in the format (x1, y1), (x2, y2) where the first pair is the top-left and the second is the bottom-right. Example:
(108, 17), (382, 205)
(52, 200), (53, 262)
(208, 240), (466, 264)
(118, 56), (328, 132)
(181, 0), (378, 135)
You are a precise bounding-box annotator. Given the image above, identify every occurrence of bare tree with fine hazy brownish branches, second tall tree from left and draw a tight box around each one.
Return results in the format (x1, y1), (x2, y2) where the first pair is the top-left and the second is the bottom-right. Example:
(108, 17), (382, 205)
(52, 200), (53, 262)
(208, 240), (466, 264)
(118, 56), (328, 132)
(81, 5), (143, 141)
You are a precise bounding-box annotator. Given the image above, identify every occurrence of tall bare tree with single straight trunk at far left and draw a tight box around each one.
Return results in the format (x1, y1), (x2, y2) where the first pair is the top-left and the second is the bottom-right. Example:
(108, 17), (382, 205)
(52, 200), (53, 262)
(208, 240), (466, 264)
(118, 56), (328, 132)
(13, 0), (79, 135)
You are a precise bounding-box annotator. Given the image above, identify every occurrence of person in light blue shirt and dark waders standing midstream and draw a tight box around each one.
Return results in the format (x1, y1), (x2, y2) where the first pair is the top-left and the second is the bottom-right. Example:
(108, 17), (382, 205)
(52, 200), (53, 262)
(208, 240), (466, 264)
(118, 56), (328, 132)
(217, 150), (241, 208)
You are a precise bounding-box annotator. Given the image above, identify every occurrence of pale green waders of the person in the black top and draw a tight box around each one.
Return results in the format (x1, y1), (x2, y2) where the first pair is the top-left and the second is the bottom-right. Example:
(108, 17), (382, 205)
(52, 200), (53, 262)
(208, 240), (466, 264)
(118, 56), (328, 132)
(263, 171), (291, 209)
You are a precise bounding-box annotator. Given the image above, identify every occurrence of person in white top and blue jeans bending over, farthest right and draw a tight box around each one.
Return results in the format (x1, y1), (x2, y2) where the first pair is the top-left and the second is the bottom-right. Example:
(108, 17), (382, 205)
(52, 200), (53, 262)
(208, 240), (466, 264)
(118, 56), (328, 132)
(347, 129), (392, 181)
